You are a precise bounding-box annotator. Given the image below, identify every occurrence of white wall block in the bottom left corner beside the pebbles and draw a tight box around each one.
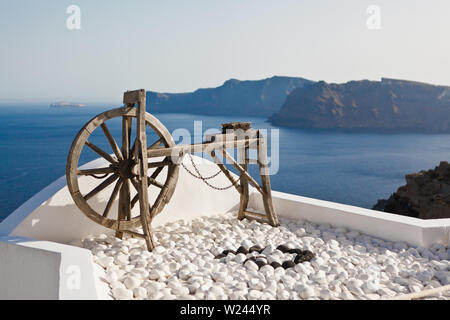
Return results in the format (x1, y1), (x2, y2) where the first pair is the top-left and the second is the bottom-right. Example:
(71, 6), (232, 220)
(0, 237), (106, 300)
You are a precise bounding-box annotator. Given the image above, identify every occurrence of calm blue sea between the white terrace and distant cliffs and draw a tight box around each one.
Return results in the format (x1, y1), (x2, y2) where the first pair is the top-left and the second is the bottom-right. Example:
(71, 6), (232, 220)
(0, 106), (450, 220)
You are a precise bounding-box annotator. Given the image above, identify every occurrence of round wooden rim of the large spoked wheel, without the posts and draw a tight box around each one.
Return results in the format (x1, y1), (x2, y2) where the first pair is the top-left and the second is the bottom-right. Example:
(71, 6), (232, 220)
(66, 107), (179, 231)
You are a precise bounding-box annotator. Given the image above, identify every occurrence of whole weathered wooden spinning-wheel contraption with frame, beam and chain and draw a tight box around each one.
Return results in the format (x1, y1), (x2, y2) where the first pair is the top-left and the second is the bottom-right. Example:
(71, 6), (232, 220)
(66, 89), (279, 250)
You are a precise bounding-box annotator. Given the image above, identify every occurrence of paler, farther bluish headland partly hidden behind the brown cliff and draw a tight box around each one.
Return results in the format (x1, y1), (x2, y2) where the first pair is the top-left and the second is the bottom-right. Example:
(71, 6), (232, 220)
(147, 76), (312, 117)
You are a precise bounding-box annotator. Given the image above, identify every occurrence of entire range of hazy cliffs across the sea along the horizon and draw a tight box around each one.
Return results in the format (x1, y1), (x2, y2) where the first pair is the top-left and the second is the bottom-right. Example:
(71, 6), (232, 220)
(147, 76), (450, 133)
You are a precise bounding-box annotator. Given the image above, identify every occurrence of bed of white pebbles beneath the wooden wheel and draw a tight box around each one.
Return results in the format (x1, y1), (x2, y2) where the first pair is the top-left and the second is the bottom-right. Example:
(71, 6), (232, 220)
(82, 213), (450, 300)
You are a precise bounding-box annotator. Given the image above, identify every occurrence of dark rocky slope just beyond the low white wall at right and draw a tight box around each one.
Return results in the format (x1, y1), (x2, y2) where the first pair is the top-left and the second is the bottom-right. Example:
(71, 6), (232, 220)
(373, 162), (450, 219)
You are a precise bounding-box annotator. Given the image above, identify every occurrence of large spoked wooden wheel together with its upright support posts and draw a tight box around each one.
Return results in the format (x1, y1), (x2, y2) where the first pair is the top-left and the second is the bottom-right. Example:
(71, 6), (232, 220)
(66, 90), (179, 250)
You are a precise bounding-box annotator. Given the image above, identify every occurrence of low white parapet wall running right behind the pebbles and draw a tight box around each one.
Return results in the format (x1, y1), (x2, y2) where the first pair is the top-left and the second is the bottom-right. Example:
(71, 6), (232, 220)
(249, 191), (450, 247)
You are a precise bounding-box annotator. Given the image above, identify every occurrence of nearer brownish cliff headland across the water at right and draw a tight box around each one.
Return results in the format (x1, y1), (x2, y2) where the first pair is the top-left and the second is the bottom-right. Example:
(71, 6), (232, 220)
(269, 78), (450, 132)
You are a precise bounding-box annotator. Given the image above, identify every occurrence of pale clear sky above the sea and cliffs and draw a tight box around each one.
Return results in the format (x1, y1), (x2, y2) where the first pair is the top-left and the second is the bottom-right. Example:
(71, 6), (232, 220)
(0, 0), (450, 103)
